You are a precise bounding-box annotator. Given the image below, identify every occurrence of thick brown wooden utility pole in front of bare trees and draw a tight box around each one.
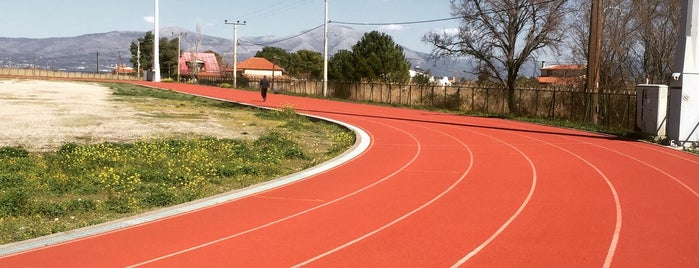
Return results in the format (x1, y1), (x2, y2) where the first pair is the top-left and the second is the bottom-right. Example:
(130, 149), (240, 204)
(586, 0), (604, 125)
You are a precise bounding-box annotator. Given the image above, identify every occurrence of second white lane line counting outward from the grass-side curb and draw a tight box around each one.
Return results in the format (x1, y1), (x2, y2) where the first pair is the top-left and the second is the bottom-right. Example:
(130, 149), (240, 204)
(291, 122), (473, 268)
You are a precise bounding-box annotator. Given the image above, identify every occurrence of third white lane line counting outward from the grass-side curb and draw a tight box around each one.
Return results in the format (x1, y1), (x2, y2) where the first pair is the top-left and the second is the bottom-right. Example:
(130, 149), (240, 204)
(451, 130), (537, 268)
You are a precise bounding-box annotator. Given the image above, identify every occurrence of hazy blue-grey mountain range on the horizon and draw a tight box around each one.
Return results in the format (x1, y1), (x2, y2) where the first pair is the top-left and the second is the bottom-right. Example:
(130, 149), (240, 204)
(0, 25), (469, 77)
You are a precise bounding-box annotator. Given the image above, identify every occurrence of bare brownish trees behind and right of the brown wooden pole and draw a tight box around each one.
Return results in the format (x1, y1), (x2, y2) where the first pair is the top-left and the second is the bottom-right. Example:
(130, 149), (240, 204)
(570, 0), (680, 92)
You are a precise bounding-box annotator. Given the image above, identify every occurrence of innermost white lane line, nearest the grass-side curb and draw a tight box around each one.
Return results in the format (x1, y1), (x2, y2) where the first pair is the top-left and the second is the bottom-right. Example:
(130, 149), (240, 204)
(127, 120), (422, 268)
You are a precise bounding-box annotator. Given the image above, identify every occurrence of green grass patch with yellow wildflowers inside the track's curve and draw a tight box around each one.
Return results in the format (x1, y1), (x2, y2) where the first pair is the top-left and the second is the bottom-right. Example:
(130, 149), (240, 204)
(0, 84), (354, 244)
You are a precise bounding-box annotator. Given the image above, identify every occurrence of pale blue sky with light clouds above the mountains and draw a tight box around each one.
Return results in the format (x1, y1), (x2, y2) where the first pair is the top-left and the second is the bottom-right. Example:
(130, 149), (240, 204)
(0, 0), (459, 52)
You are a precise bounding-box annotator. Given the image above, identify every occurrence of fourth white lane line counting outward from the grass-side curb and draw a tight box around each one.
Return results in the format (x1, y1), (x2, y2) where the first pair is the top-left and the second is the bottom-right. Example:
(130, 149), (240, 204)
(518, 134), (622, 268)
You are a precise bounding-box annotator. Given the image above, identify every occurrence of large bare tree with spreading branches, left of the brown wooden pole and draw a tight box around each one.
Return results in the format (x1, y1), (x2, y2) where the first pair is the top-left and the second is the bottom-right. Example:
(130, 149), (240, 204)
(423, 0), (567, 113)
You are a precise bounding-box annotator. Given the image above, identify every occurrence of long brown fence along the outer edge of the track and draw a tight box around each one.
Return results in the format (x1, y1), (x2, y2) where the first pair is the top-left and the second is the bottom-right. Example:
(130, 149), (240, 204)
(238, 77), (636, 130)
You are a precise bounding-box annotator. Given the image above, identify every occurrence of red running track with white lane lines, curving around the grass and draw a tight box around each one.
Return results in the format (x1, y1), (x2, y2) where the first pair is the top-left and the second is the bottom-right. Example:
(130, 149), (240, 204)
(0, 83), (699, 267)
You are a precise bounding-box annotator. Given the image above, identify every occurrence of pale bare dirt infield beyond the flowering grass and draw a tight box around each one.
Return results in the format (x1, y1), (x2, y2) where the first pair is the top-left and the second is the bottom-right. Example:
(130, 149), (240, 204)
(0, 80), (256, 151)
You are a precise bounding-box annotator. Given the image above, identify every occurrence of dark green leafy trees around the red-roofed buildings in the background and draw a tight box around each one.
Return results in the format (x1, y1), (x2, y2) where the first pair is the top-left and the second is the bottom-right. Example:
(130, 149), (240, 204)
(130, 31), (410, 82)
